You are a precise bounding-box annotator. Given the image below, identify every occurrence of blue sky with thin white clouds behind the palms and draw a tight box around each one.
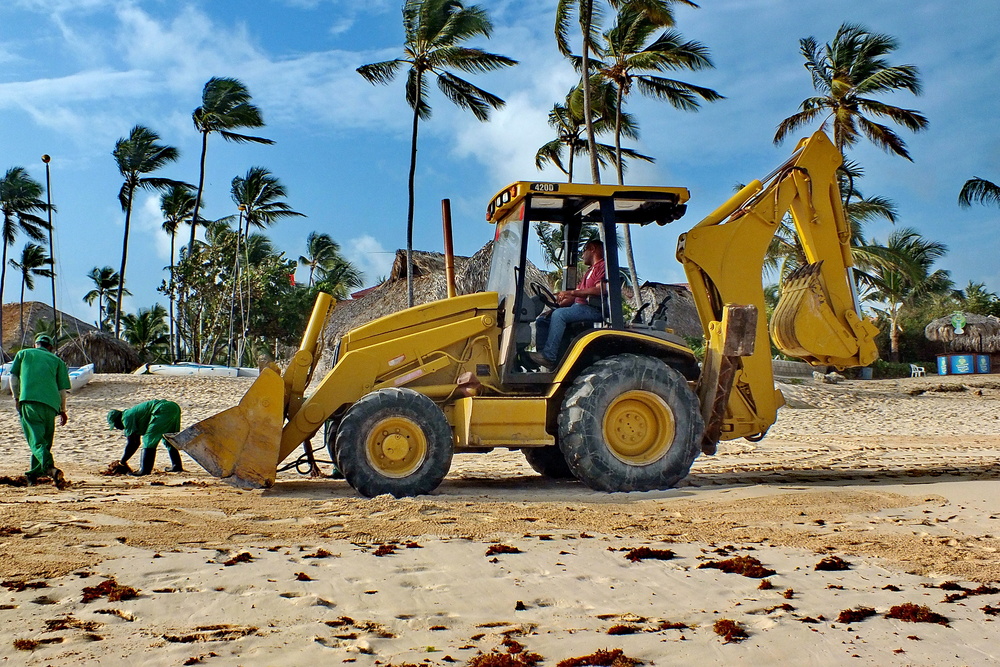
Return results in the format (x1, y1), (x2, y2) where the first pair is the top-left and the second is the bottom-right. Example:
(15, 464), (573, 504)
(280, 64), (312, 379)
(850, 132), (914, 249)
(0, 0), (1000, 321)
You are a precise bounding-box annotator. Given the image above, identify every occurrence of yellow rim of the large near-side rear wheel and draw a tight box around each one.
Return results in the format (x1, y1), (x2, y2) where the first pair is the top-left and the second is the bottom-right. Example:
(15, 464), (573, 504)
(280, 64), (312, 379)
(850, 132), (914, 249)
(604, 391), (676, 465)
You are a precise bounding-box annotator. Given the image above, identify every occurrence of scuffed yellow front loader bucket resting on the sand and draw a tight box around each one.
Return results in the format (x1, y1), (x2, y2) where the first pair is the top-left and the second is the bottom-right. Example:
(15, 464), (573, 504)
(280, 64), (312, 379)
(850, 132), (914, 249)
(164, 368), (285, 489)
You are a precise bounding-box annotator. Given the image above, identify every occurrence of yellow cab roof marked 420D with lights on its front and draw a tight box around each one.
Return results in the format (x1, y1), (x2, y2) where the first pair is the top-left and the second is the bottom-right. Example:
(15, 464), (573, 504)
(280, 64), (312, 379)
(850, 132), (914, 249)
(486, 181), (691, 225)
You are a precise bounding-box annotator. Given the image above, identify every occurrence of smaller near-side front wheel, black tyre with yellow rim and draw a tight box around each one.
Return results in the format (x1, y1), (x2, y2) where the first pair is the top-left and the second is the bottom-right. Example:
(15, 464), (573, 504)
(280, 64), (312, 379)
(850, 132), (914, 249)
(335, 389), (454, 498)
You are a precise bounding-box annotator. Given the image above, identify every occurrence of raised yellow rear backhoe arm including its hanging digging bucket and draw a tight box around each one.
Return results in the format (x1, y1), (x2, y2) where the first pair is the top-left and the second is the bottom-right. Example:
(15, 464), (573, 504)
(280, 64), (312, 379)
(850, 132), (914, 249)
(677, 132), (878, 440)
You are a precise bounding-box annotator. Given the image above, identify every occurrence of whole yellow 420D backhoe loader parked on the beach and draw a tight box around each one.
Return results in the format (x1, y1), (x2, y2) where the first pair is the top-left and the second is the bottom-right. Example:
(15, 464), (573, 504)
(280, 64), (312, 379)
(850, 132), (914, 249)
(169, 132), (877, 497)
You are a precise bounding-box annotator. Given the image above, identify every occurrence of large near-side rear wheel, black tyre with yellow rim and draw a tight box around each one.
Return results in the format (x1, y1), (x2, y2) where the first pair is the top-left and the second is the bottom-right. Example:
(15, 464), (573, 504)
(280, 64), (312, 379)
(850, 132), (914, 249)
(559, 354), (704, 491)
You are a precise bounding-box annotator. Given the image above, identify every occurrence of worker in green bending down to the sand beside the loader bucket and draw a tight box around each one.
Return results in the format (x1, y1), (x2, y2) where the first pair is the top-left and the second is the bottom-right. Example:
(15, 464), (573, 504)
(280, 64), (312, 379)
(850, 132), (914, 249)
(108, 399), (184, 477)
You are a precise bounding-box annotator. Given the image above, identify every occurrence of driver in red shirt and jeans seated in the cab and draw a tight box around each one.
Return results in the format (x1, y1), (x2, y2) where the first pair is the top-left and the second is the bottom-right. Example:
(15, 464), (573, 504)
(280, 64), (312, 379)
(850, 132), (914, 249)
(528, 239), (605, 369)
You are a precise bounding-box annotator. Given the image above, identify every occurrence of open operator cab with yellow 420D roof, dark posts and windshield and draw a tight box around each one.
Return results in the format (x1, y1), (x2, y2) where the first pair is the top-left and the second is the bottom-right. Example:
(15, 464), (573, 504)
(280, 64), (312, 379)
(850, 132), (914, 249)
(486, 181), (689, 385)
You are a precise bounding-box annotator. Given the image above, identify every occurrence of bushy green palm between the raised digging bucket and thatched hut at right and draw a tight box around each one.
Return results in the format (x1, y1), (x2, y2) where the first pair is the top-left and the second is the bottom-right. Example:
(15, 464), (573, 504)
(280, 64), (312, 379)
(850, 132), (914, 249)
(862, 227), (954, 361)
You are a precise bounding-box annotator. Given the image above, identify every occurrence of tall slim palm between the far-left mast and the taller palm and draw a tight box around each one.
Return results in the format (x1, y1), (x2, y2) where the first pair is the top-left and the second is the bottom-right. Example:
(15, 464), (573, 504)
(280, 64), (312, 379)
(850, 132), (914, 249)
(111, 125), (183, 336)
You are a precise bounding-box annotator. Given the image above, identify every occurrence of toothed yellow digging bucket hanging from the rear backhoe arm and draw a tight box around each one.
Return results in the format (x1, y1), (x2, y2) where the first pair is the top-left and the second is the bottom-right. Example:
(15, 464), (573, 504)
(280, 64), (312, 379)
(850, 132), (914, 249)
(771, 262), (877, 367)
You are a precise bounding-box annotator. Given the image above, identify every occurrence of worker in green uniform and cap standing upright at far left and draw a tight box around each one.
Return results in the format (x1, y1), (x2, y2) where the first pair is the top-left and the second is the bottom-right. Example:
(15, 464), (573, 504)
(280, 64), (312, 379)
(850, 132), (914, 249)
(10, 334), (70, 489)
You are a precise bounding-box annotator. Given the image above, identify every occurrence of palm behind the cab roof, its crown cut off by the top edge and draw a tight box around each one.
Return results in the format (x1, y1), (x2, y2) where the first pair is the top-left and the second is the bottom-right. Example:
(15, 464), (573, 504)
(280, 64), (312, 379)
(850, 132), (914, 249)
(555, 0), (698, 183)
